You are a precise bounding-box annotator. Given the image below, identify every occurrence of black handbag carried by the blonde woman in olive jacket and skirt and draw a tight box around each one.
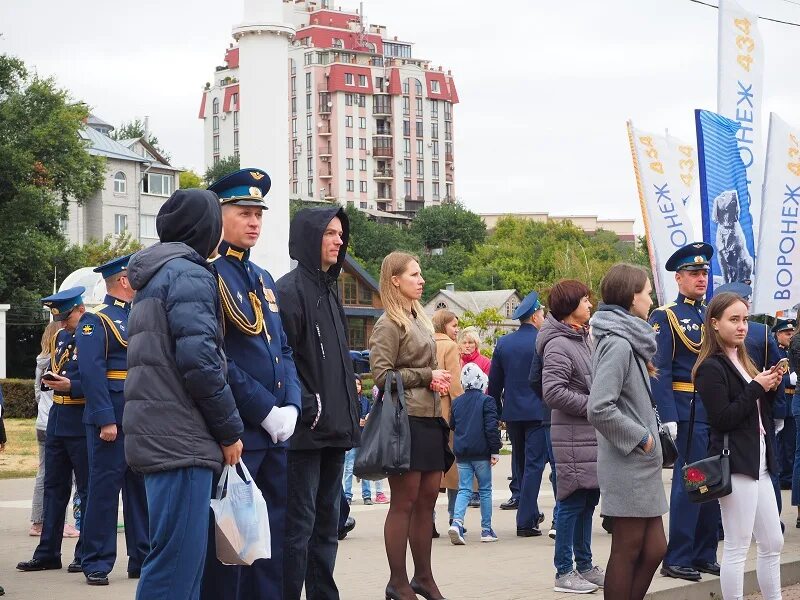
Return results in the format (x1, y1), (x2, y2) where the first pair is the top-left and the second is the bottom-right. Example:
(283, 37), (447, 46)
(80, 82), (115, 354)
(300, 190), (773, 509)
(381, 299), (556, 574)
(353, 371), (411, 481)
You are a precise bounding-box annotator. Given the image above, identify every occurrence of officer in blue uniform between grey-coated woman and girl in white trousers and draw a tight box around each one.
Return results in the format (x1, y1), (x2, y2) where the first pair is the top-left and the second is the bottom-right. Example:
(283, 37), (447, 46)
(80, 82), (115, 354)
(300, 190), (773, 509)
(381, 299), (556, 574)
(650, 243), (720, 581)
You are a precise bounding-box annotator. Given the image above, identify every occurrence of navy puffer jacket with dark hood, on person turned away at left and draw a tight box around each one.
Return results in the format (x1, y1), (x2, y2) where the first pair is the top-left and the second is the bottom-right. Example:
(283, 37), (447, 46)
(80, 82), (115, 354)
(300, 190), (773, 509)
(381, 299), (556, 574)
(123, 190), (244, 473)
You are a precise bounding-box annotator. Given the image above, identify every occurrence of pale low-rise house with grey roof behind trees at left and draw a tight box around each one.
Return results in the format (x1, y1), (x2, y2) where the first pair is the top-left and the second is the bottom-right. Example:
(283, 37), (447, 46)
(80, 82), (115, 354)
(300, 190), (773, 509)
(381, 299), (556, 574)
(61, 114), (181, 246)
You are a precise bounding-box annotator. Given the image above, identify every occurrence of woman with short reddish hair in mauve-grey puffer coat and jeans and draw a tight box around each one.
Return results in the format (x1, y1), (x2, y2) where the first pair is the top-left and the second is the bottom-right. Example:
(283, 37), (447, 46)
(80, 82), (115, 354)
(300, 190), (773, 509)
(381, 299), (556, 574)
(536, 279), (610, 597)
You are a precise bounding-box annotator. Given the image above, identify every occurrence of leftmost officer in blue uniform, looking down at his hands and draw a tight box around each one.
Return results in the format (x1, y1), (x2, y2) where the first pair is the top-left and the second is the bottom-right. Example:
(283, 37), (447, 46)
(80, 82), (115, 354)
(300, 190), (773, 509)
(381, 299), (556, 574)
(17, 287), (89, 573)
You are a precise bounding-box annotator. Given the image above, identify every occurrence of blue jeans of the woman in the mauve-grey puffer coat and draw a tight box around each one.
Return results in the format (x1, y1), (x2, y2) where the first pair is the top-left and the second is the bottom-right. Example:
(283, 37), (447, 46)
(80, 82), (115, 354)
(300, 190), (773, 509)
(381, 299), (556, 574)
(553, 490), (600, 576)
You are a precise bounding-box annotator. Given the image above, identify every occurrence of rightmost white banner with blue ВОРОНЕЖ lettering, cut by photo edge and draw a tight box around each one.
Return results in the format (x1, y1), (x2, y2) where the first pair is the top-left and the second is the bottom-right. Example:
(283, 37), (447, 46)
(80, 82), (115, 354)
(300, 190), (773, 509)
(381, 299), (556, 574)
(753, 113), (800, 315)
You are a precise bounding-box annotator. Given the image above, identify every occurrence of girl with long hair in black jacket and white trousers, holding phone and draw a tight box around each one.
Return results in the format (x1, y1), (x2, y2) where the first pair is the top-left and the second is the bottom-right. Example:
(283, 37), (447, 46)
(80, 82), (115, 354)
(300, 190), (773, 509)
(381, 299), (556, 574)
(692, 292), (783, 600)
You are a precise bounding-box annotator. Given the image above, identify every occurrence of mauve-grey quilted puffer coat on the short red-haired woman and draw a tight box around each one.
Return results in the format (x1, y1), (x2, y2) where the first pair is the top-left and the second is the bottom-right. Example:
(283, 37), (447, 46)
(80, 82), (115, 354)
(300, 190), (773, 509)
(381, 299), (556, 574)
(536, 314), (599, 500)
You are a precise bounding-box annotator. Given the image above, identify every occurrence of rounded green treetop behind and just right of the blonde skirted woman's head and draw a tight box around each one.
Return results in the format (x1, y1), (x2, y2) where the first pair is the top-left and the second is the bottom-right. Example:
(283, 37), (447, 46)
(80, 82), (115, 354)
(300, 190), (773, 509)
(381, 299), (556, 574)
(411, 204), (486, 250)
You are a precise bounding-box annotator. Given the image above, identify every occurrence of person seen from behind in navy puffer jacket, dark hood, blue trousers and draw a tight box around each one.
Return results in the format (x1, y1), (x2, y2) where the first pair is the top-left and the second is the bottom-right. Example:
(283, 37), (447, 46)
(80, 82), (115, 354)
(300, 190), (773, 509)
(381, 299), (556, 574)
(123, 189), (244, 600)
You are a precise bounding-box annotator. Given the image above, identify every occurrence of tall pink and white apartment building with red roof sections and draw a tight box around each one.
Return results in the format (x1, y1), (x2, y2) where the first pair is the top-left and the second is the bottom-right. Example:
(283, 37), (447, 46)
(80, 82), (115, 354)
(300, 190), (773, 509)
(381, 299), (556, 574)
(199, 0), (458, 216)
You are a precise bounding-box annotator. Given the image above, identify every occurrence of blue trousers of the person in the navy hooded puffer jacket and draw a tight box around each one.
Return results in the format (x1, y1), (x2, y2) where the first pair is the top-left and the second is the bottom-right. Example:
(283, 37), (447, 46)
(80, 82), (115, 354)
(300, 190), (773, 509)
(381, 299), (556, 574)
(136, 467), (214, 600)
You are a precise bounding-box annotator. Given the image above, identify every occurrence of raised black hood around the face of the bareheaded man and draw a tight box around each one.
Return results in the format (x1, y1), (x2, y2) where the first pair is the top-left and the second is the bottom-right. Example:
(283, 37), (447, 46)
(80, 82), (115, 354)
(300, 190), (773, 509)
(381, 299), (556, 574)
(289, 206), (350, 280)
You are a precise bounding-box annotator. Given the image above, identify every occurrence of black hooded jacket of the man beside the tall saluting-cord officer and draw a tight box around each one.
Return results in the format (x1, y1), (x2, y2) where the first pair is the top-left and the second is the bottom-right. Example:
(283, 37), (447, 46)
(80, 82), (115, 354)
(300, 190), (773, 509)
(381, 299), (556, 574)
(277, 207), (361, 450)
